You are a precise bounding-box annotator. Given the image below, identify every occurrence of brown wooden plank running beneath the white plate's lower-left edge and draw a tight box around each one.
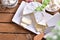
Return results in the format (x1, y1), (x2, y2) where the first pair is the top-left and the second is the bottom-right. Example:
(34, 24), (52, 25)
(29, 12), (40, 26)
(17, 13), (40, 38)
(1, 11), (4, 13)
(0, 23), (30, 33)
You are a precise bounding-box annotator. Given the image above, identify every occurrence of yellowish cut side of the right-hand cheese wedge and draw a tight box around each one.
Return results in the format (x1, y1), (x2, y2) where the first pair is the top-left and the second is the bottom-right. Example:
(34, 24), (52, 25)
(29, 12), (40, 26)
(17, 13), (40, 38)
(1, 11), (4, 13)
(30, 13), (47, 32)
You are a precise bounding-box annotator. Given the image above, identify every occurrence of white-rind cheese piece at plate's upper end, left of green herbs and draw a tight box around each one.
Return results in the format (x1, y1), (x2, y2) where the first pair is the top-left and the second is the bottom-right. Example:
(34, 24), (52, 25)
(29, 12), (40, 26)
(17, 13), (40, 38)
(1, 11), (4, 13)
(23, 2), (41, 15)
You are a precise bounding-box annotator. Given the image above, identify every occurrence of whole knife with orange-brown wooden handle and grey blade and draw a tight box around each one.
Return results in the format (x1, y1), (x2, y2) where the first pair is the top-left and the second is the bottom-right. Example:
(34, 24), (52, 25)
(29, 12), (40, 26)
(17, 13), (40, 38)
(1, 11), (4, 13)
(34, 26), (55, 40)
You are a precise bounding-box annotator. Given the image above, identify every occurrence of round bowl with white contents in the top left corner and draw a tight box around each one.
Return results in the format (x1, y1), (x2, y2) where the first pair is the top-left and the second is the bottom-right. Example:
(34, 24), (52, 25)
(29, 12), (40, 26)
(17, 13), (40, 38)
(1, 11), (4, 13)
(1, 0), (18, 8)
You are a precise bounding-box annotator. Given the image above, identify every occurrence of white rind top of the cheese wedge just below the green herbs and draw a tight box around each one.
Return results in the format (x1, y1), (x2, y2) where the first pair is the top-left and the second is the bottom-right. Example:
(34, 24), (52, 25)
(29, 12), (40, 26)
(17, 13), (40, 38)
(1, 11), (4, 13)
(34, 11), (46, 26)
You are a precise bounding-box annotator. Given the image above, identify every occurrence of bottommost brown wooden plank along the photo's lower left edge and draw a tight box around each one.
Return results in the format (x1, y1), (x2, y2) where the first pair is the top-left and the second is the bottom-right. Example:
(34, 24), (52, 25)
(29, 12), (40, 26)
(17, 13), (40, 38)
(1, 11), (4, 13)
(0, 34), (32, 40)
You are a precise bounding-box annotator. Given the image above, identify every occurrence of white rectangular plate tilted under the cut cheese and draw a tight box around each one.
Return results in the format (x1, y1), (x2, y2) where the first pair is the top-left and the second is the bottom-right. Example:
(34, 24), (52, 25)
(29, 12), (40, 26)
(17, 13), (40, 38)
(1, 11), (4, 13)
(12, 1), (53, 34)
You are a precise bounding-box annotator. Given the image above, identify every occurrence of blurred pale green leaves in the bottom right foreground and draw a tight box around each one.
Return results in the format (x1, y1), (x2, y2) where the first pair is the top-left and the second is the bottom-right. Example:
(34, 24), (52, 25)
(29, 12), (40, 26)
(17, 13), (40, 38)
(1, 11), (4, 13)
(46, 21), (60, 40)
